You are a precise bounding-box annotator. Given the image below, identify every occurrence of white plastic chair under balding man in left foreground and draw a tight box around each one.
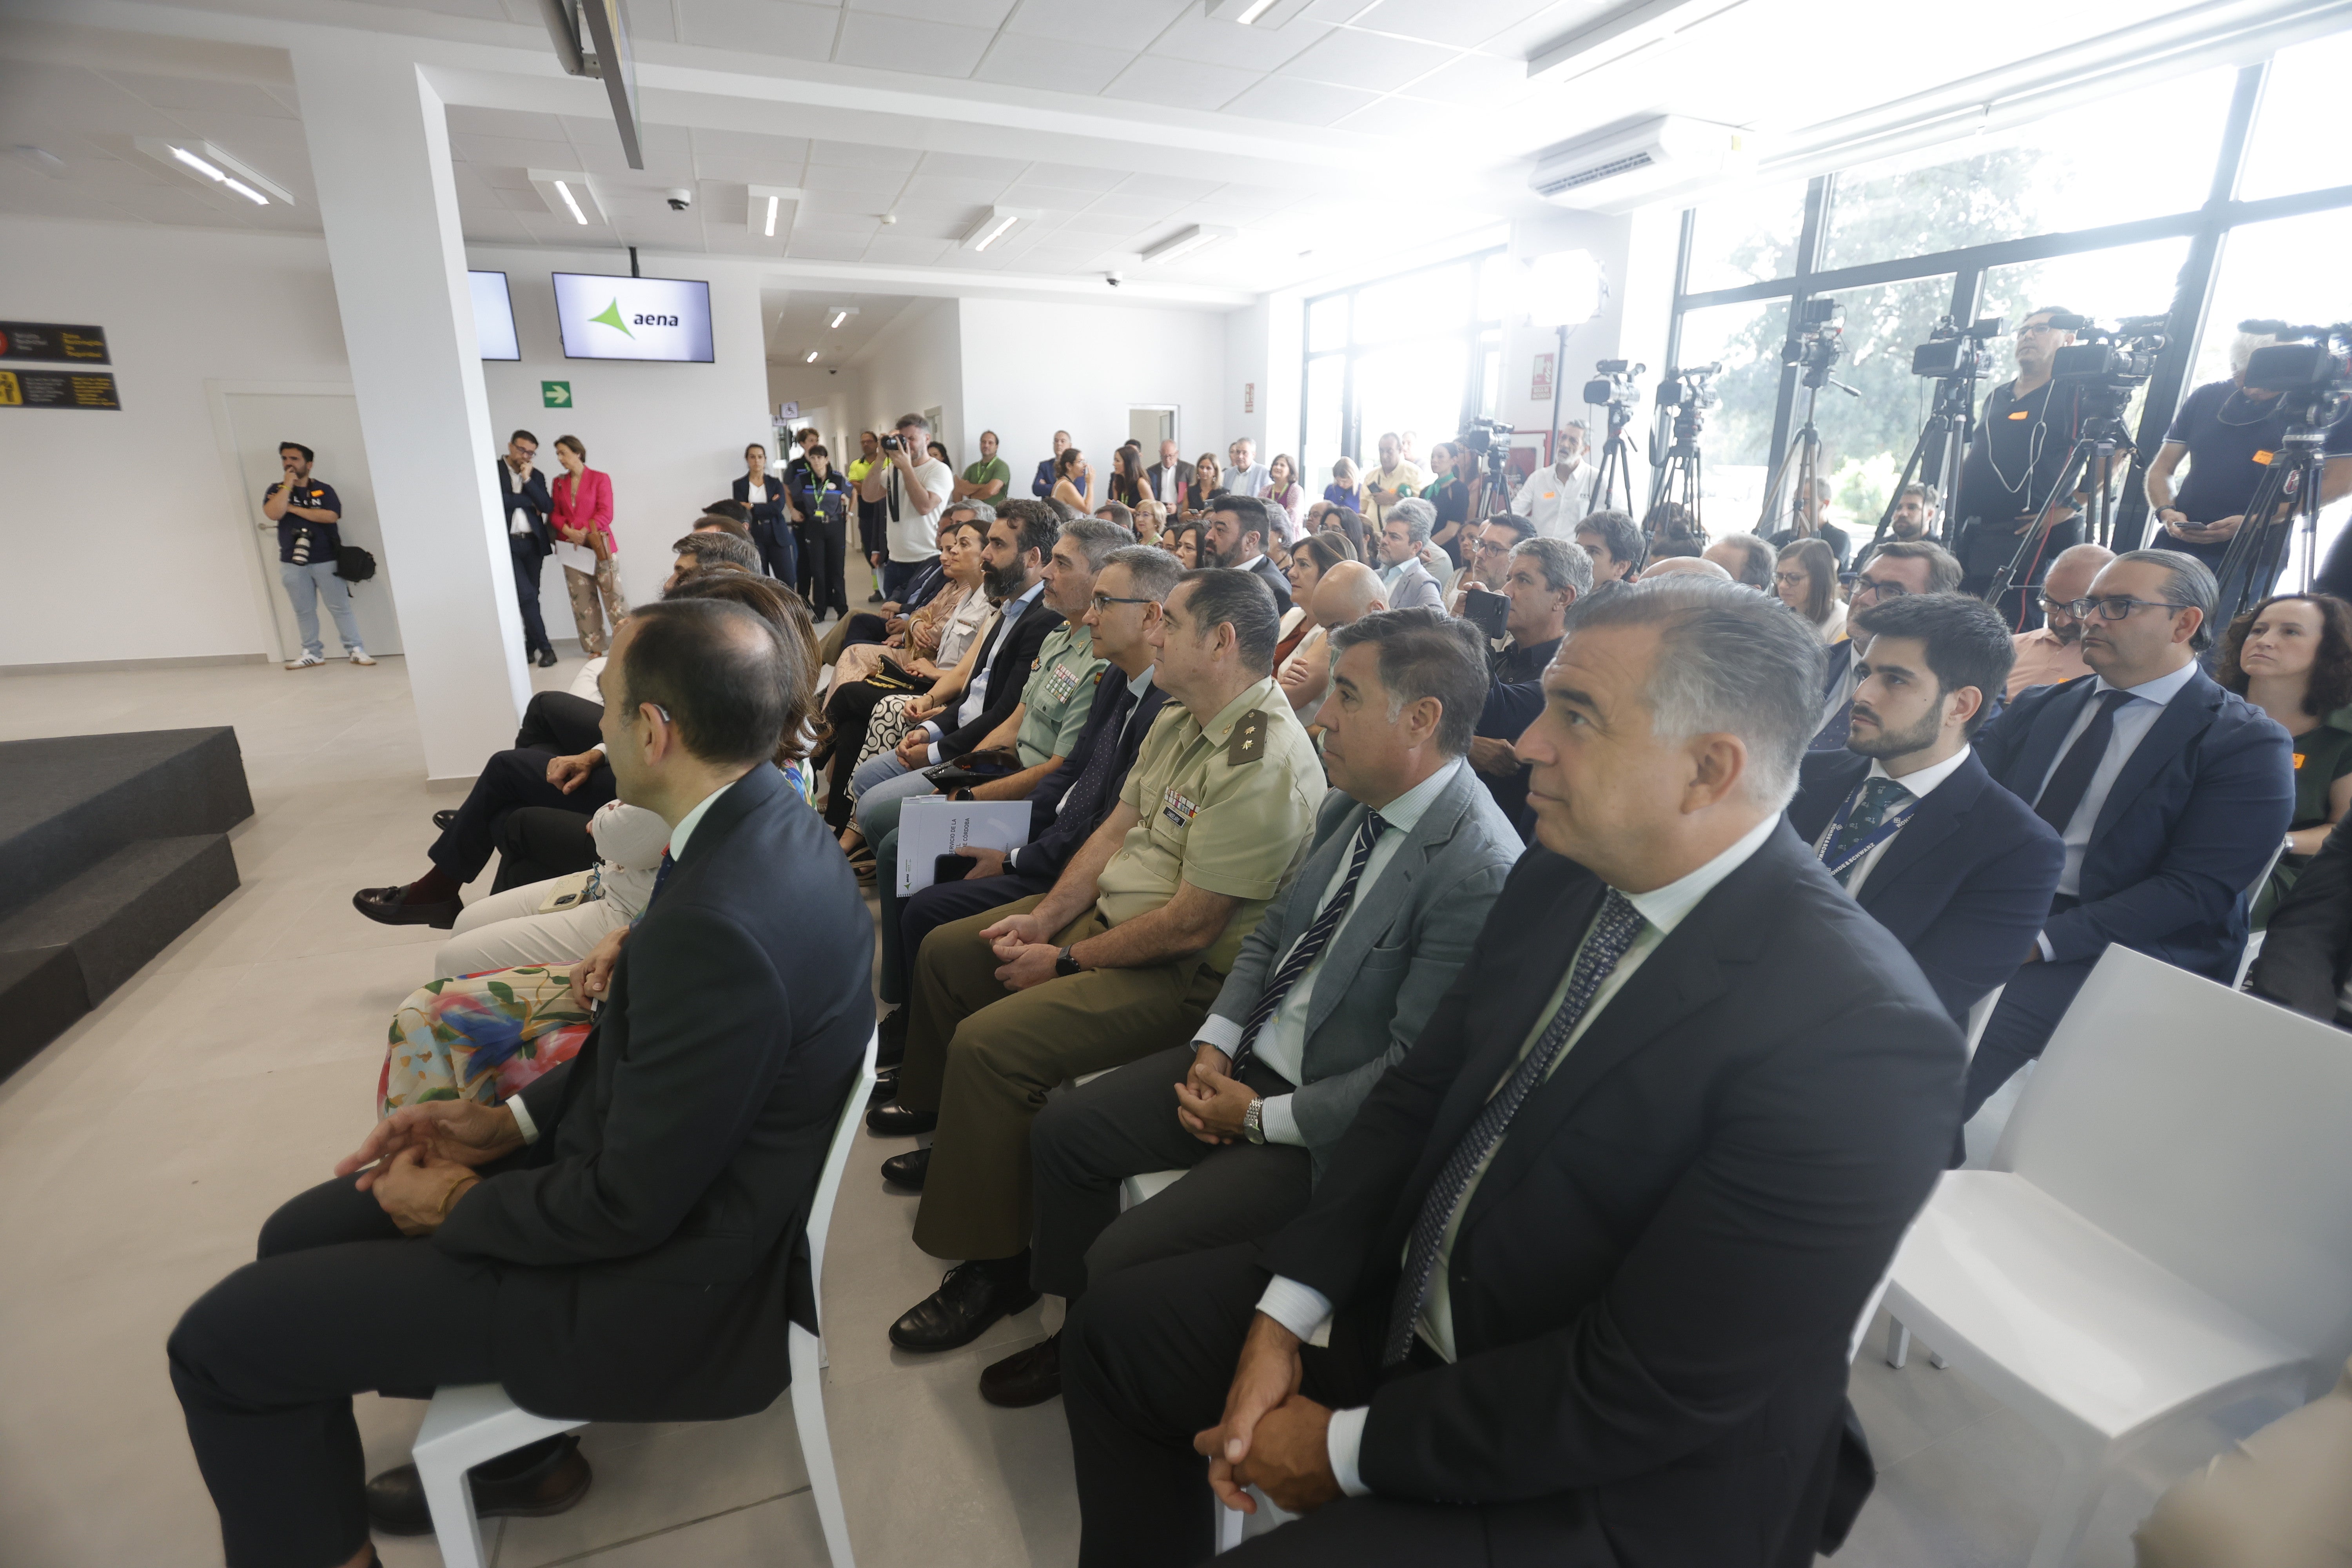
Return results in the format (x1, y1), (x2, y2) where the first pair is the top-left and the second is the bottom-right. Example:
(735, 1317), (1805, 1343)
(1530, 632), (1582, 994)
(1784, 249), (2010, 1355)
(414, 1037), (875, 1568)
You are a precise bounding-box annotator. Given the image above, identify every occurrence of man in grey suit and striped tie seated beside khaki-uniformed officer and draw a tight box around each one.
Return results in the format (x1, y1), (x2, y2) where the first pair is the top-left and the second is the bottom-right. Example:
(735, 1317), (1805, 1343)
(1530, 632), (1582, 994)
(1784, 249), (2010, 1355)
(981, 609), (1522, 1406)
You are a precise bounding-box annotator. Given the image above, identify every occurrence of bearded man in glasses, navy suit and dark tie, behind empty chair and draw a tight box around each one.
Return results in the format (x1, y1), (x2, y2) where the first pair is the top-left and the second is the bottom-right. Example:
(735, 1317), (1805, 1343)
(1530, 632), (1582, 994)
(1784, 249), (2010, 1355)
(1964, 550), (2296, 1117)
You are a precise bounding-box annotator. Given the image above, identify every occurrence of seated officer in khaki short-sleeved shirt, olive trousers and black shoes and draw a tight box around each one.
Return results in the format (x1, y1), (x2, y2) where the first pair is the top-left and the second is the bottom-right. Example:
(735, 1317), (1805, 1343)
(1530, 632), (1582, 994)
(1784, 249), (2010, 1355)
(875, 566), (1327, 1349)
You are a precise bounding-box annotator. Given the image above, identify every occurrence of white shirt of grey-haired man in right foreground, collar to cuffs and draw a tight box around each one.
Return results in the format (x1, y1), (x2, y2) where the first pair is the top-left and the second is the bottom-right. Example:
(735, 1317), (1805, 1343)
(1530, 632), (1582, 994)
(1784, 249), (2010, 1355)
(1258, 816), (1780, 1497)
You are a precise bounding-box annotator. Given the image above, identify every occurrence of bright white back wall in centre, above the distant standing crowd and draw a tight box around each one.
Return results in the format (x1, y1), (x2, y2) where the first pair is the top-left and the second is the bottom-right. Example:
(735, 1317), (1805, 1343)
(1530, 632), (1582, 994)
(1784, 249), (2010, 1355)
(955, 299), (1242, 496)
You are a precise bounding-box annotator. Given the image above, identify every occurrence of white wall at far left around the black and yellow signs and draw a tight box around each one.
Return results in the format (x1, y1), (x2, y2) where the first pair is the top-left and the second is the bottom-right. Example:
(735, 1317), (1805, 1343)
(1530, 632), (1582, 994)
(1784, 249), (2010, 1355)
(0, 219), (350, 665)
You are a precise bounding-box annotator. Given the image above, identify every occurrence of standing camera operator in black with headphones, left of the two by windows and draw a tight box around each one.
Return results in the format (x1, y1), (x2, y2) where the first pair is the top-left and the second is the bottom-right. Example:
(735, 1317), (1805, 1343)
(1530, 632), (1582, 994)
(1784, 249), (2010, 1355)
(1952, 308), (2082, 632)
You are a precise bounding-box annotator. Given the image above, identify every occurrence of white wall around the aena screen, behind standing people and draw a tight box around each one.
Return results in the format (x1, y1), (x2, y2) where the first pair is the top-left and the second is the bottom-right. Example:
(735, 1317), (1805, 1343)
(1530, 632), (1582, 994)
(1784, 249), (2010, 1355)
(466, 247), (776, 621)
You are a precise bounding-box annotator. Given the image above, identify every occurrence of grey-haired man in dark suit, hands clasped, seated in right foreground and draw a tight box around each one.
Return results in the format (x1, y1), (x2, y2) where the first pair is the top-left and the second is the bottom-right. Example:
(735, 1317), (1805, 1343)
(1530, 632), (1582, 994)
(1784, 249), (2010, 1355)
(1063, 576), (1962, 1568)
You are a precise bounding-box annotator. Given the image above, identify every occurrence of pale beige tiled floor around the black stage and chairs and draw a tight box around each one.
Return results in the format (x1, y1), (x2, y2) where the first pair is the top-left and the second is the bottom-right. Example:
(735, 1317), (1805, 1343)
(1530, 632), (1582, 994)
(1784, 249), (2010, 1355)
(0, 658), (2230, 1568)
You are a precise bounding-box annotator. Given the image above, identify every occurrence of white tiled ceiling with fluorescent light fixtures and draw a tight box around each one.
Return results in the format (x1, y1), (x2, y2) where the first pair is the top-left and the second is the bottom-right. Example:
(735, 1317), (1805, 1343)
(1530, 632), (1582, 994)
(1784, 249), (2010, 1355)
(0, 0), (2249, 315)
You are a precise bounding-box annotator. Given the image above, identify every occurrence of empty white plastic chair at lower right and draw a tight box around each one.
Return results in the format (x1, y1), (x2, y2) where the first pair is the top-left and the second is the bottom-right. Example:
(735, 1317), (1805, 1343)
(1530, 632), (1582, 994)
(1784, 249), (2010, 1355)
(1886, 947), (2352, 1568)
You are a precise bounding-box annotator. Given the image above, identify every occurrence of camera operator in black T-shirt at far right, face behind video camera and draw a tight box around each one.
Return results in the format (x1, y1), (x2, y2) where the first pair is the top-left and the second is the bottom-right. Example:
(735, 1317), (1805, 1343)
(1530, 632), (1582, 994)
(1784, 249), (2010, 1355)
(2147, 332), (2352, 576)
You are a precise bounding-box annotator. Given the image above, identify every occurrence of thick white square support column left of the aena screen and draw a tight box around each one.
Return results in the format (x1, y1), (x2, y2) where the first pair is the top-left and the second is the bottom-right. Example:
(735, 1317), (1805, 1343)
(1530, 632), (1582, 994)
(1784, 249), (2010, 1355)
(292, 38), (529, 780)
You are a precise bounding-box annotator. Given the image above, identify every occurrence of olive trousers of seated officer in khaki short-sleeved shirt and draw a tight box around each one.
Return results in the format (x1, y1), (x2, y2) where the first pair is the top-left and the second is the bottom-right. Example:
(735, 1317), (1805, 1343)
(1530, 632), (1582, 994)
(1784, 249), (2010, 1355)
(898, 898), (1225, 1258)
